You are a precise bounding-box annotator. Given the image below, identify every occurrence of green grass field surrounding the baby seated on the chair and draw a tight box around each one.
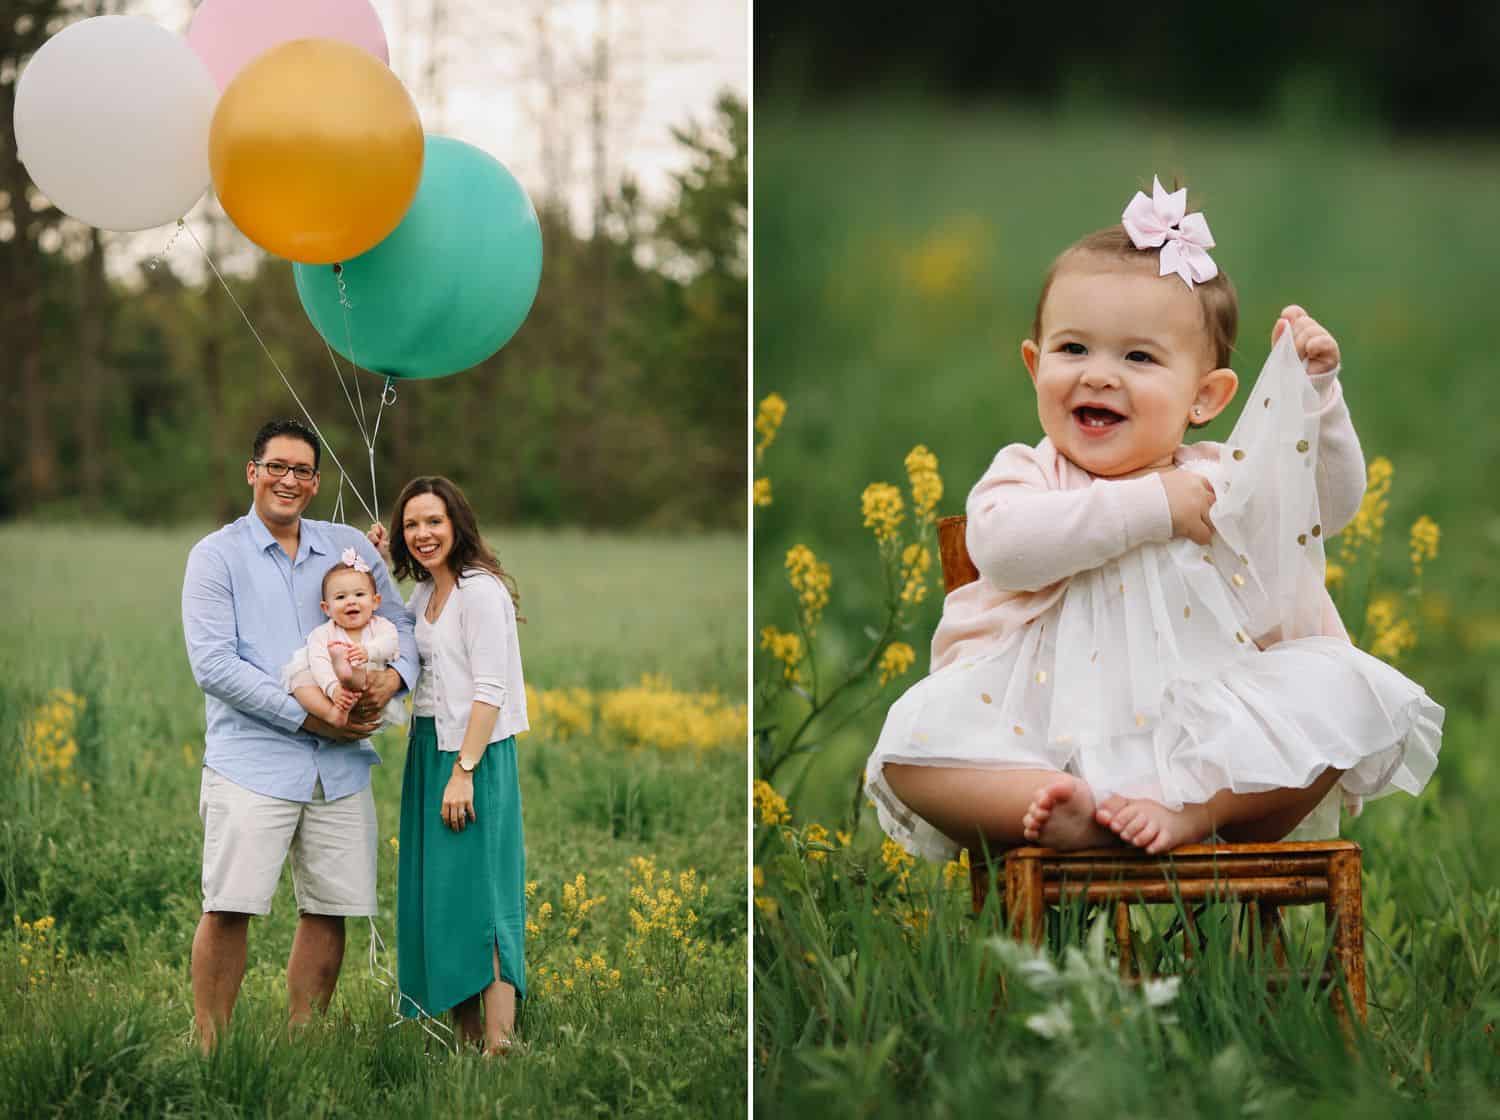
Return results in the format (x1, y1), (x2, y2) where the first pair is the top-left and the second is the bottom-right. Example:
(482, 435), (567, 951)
(753, 103), (1500, 1116)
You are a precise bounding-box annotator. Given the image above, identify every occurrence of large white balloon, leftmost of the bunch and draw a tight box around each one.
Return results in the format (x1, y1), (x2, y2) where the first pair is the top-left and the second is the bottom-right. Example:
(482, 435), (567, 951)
(15, 15), (219, 229)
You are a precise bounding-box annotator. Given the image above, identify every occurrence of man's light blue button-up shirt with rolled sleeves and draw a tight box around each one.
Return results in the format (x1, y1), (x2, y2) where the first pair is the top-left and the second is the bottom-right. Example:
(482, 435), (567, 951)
(183, 505), (419, 801)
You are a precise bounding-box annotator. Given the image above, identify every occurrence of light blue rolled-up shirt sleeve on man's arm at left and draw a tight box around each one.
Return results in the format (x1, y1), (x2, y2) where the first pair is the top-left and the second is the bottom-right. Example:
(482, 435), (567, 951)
(183, 541), (308, 733)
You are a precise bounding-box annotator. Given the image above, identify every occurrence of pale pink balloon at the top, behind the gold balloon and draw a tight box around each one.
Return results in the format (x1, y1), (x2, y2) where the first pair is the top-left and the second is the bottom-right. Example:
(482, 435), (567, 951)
(188, 0), (390, 91)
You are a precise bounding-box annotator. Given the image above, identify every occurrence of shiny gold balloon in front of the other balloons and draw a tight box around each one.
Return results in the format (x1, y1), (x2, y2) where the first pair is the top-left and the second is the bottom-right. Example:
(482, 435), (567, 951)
(209, 39), (423, 264)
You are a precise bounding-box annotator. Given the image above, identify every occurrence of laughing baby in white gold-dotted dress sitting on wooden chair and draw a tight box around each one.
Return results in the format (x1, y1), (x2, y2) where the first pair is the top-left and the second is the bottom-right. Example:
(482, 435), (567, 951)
(866, 181), (1443, 859)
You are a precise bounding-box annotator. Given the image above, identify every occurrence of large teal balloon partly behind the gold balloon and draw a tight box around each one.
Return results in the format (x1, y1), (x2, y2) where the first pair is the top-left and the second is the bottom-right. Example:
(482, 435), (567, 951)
(294, 136), (542, 378)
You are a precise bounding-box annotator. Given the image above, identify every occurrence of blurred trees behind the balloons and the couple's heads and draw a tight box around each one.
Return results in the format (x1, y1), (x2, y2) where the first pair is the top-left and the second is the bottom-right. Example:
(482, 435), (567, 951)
(0, 0), (749, 528)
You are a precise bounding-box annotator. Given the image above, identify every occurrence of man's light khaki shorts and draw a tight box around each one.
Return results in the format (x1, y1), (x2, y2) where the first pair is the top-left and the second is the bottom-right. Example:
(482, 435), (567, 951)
(198, 766), (377, 916)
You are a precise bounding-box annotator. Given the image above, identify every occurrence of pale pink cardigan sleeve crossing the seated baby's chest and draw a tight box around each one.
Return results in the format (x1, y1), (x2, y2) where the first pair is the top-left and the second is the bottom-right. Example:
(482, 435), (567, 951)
(968, 441), (1172, 591)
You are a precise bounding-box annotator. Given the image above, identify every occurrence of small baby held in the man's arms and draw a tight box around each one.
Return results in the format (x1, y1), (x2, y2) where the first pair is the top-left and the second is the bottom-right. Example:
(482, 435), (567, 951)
(282, 549), (407, 727)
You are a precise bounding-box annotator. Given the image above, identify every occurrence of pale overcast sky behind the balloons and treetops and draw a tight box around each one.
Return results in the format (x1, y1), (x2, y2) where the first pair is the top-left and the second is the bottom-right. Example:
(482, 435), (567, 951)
(111, 0), (750, 273)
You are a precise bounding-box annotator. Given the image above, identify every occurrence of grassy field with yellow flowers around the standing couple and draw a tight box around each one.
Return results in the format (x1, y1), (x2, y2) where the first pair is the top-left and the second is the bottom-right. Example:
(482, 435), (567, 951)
(0, 525), (747, 1117)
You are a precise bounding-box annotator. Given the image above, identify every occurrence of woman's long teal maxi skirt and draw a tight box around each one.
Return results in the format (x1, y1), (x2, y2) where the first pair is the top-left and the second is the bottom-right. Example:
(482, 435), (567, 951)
(396, 717), (527, 1018)
